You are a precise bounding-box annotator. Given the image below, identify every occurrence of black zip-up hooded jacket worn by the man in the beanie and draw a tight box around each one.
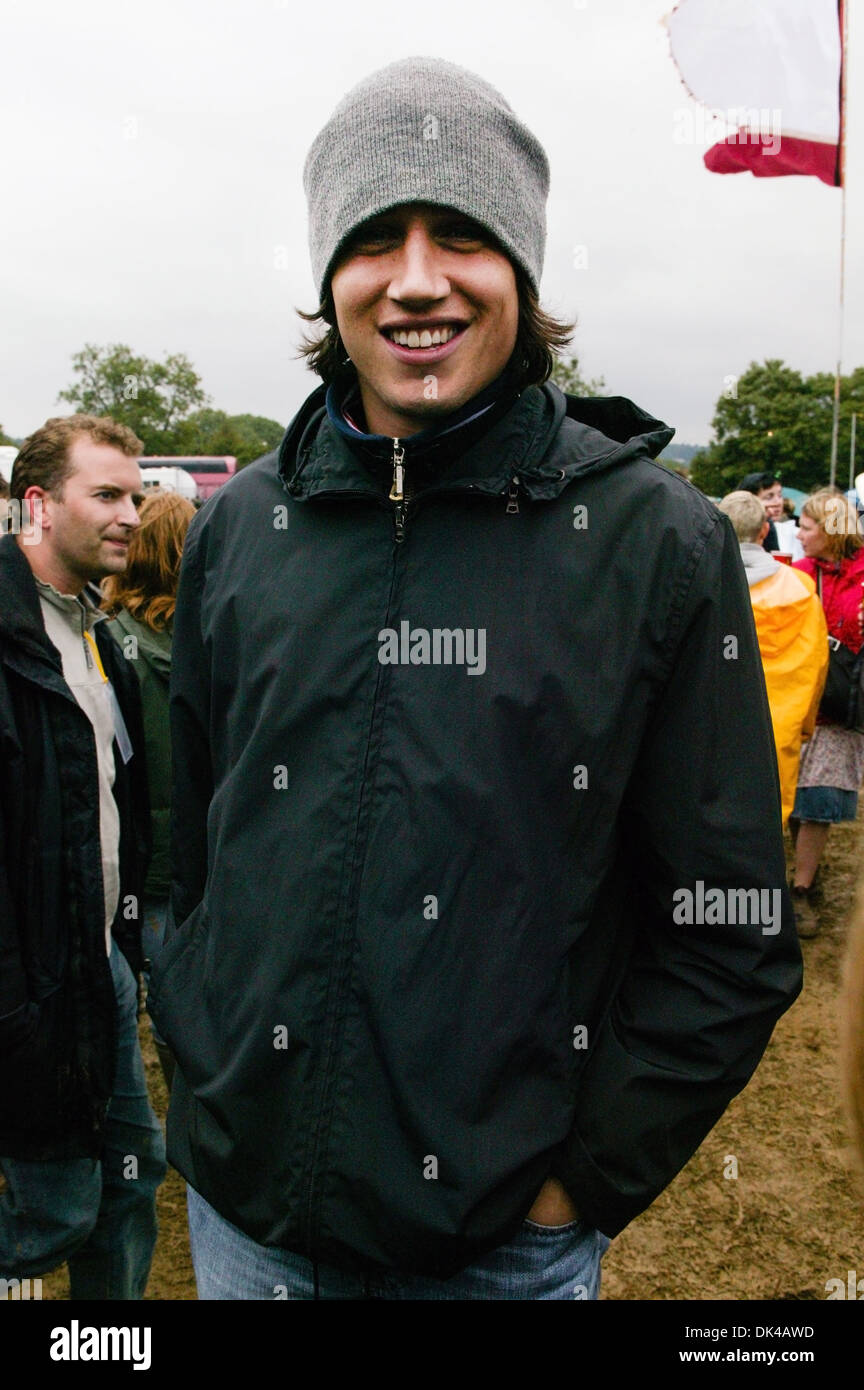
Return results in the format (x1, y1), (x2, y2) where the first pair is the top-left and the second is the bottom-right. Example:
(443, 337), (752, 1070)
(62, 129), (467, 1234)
(151, 385), (800, 1276)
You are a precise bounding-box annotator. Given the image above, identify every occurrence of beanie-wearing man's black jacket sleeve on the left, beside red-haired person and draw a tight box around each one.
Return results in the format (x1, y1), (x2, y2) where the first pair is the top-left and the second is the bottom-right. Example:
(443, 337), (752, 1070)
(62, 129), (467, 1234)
(168, 521), (213, 934)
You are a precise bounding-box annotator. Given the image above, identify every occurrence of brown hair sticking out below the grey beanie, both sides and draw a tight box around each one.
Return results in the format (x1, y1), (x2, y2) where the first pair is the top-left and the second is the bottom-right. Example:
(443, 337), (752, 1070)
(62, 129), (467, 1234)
(297, 261), (574, 389)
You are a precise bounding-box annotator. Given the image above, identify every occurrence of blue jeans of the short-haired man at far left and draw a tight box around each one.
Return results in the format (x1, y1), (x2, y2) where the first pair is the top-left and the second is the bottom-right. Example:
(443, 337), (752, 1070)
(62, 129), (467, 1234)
(0, 945), (165, 1298)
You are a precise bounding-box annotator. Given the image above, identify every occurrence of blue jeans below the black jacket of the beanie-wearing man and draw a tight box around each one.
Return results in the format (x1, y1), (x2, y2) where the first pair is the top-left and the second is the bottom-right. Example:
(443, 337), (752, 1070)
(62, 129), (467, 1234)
(186, 1187), (610, 1300)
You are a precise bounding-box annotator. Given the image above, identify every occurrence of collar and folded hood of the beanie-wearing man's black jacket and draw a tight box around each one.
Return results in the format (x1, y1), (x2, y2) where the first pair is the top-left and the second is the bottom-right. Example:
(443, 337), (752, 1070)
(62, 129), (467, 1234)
(278, 382), (675, 500)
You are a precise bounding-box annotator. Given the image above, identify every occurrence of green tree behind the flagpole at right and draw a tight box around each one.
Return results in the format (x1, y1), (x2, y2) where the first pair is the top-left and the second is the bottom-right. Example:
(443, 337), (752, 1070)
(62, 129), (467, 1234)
(690, 357), (864, 496)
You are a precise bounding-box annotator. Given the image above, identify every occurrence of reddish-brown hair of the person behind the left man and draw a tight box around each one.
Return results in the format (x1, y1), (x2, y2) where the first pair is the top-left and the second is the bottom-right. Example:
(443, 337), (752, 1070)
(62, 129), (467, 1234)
(101, 492), (194, 632)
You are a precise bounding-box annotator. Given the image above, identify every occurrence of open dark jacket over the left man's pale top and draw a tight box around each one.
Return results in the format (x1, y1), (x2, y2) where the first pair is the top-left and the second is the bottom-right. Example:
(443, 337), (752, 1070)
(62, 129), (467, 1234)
(0, 535), (149, 1159)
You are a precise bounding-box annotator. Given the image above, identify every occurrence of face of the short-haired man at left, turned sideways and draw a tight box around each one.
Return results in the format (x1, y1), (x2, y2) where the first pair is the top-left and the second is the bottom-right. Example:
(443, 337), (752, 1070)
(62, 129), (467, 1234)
(26, 435), (142, 594)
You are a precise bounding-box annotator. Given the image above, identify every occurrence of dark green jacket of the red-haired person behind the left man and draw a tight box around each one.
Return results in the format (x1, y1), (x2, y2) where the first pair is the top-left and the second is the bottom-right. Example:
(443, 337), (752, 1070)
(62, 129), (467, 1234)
(107, 609), (171, 899)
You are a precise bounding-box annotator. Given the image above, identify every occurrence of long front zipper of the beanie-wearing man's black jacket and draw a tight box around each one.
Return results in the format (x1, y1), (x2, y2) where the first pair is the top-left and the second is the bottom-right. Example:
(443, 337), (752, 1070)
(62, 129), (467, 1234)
(306, 497), (407, 1261)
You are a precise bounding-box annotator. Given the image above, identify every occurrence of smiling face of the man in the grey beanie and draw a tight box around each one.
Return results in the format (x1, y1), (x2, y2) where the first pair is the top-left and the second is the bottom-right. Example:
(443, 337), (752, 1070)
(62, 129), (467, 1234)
(332, 203), (518, 438)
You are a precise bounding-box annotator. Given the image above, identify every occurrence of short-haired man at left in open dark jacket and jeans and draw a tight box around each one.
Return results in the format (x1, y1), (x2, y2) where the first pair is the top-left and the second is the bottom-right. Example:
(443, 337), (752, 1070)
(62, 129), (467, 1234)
(0, 416), (165, 1298)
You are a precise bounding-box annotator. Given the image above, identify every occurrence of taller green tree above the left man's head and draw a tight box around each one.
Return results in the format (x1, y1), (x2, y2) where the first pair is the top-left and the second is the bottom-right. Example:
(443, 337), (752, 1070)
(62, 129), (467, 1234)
(58, 343), (210, 453)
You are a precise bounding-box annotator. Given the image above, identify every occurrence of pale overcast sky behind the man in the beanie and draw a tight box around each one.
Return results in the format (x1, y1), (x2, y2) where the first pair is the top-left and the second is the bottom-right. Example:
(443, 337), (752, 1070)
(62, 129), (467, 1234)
(0, 0), (864, 443)
